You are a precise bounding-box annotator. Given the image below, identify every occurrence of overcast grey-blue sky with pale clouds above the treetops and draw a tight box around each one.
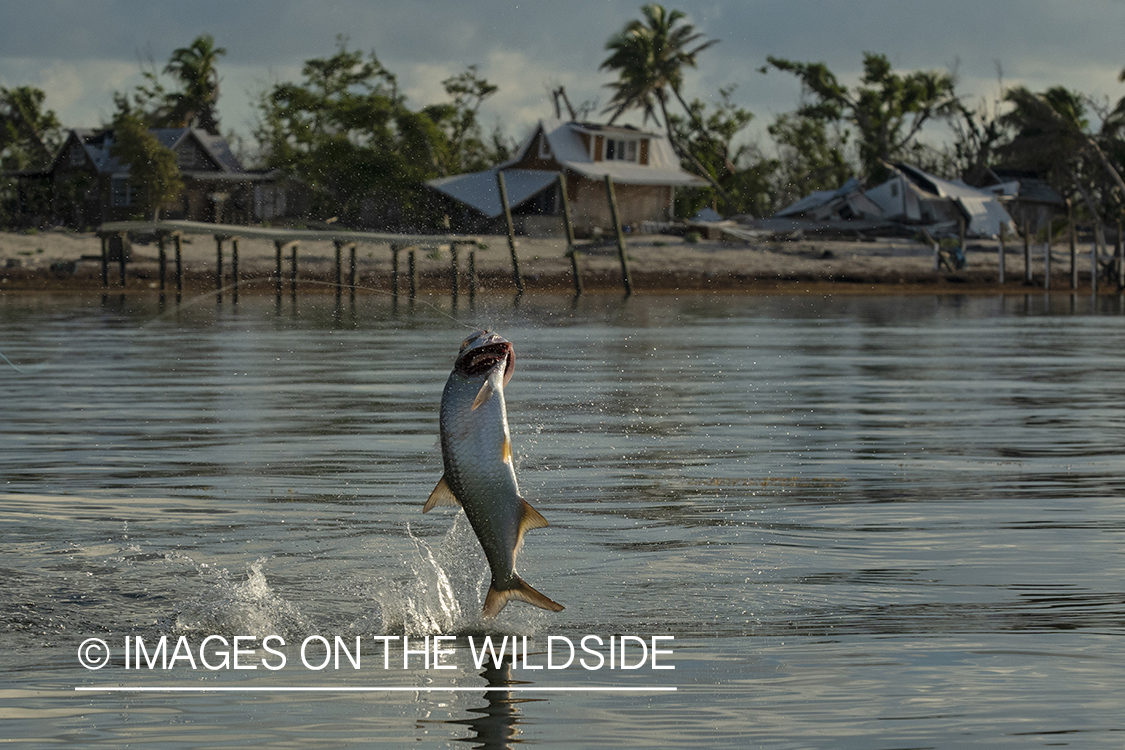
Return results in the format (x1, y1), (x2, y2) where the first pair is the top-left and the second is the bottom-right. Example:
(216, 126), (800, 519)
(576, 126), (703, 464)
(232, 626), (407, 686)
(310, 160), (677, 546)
(0, 0), (1125, 154)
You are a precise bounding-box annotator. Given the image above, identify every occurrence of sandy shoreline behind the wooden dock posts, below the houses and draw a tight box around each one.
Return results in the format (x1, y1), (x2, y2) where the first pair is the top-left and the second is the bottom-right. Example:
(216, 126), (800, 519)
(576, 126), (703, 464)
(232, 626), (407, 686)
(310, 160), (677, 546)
(0, 232), (1116, 293)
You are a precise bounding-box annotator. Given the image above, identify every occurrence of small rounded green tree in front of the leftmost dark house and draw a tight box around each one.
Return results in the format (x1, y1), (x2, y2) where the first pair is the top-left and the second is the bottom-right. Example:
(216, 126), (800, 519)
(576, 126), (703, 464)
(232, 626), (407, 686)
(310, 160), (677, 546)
(110, 115), (183, 222)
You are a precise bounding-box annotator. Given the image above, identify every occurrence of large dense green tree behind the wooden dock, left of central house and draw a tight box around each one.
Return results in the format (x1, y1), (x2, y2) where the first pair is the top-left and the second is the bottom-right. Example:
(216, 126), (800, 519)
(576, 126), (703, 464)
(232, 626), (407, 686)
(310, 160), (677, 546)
(255, 37), (506, 225)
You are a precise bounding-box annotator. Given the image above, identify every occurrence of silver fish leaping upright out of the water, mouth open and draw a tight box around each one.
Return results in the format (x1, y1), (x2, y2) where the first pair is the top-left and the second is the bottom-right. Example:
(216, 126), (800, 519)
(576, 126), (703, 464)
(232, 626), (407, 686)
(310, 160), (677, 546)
(422, 332), (563, 617)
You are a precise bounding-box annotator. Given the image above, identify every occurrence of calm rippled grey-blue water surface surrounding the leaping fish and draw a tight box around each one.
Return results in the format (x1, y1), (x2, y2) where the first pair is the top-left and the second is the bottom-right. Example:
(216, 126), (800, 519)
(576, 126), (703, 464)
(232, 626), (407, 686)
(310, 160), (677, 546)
(0, 295), (1125, 749)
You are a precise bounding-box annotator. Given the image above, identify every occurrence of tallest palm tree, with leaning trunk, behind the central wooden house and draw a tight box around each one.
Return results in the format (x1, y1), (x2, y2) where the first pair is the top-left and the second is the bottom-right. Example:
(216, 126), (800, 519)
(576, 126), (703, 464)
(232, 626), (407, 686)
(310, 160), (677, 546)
(601, 2), (730, 204)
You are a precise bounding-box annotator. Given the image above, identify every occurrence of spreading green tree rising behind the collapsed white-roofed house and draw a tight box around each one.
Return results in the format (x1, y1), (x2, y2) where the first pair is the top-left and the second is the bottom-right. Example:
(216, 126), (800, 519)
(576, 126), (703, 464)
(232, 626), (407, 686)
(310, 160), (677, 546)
(767, 52), (957, 182)
